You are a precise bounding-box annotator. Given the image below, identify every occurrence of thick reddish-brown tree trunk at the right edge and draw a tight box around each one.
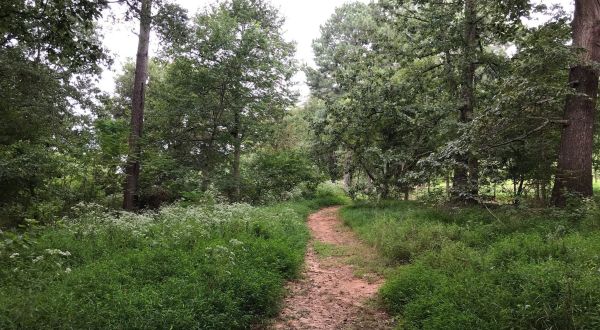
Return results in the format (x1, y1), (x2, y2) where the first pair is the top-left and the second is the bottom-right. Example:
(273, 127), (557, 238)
(552, 0), (600, 206)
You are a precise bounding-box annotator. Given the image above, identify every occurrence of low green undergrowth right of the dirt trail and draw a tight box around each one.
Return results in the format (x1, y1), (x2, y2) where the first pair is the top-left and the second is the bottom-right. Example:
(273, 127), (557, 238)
(342, 202), (600, 329)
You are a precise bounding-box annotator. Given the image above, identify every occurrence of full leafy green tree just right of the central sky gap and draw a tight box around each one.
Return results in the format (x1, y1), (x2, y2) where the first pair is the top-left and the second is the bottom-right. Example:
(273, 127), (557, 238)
(308, 4), (446, 198)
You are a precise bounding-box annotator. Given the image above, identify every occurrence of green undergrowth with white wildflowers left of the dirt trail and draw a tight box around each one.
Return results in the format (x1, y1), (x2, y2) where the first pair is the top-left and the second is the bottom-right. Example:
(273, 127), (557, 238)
(0, 187), (343, 329)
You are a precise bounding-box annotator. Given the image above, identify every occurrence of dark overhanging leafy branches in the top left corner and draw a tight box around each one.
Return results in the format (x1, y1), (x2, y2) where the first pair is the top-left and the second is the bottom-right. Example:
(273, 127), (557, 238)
(0, 0), (108, 73)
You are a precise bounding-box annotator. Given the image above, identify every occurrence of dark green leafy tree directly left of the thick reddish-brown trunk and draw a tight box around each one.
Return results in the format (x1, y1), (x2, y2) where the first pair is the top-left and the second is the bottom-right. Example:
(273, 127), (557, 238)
(471, 16), (572, 205)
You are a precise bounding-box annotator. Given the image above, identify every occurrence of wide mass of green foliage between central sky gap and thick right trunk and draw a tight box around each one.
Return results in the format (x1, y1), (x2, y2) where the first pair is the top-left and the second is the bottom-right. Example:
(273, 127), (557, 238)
(306, 0), (573, 203)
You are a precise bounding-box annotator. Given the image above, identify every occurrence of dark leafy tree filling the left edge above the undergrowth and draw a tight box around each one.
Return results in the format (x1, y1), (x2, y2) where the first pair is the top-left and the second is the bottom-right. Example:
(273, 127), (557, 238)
(0, 0), (107, 226)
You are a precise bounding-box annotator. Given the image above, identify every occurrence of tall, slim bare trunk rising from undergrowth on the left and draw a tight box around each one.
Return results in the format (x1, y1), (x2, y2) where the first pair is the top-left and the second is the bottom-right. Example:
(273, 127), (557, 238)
(123, 0), (152, 211)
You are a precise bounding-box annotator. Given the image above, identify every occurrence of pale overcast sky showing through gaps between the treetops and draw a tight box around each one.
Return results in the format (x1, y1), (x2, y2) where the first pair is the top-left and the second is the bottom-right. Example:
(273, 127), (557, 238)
(100, 0), (574, 96)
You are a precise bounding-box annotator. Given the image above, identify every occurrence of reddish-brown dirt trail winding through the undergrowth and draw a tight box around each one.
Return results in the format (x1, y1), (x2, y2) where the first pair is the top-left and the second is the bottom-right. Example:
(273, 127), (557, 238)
(274, 207), (391, 329)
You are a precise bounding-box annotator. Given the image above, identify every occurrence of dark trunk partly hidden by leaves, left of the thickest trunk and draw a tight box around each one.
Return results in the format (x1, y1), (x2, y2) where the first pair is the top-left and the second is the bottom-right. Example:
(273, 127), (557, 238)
(453, 0), (479, 202)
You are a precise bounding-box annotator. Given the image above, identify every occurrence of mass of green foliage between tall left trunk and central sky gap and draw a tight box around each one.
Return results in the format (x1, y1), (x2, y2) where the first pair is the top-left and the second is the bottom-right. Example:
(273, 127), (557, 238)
(105, 0), (295, 207)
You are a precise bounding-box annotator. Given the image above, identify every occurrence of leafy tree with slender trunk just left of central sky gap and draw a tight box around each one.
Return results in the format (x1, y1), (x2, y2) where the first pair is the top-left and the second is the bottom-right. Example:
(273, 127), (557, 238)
(150, 0), (295, 200)
